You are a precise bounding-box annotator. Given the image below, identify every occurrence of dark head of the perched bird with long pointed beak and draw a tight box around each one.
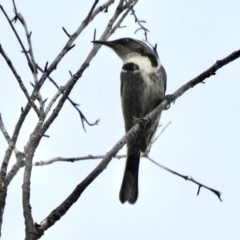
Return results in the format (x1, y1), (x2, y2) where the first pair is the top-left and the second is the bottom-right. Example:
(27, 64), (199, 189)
(93, 38), (159, 67)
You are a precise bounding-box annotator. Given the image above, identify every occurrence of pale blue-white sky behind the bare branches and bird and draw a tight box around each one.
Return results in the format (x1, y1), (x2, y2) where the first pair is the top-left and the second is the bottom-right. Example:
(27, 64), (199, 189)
(0, 0), (240, 240)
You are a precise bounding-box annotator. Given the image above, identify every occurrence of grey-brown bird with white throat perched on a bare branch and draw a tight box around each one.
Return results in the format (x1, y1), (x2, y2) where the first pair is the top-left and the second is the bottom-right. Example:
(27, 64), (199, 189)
(94, 38), (167, 204)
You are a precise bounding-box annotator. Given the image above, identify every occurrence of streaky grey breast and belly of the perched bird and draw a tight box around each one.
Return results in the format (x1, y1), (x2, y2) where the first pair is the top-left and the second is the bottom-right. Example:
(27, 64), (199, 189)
(121, 64), (164, 128)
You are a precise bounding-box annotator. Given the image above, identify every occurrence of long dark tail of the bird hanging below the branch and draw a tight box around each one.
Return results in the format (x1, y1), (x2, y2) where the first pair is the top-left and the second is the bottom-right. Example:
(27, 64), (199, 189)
(119, 151), (140, 204)
